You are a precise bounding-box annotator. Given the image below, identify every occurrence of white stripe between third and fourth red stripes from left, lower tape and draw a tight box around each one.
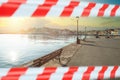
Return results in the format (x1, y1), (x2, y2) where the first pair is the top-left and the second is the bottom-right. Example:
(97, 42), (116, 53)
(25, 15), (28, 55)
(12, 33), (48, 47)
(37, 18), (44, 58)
(72, 67), (88, 80)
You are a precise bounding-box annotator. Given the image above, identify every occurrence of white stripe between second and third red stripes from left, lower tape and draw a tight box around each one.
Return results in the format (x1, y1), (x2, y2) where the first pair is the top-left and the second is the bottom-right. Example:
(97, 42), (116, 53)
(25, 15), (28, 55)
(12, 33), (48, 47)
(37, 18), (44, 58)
(50, 67), (69, 80)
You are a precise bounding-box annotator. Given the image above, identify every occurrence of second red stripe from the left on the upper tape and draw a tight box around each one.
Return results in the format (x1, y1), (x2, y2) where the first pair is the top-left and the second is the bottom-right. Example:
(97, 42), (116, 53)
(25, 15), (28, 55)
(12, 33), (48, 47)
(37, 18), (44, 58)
(32, 0), (58, 16)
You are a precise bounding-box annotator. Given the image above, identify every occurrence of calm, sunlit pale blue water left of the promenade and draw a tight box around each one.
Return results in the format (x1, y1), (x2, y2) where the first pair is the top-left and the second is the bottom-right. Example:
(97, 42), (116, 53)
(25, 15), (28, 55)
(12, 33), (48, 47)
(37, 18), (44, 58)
(0, 34), (75, 67)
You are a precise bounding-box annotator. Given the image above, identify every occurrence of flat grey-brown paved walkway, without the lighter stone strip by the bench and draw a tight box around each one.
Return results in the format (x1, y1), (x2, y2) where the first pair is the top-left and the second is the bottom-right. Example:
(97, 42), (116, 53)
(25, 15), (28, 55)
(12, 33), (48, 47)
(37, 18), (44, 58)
(67, 38), (120, 66)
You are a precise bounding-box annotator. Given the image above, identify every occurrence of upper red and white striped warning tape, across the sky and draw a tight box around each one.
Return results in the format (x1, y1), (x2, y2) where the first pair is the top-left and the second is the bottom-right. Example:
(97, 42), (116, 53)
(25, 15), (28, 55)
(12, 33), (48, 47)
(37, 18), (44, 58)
(0, 0), (120, 17)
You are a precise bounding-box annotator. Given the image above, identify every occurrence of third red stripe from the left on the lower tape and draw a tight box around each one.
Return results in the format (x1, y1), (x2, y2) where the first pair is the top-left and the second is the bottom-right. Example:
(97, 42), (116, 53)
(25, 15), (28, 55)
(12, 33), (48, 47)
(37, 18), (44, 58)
(62, 67), (78, 80)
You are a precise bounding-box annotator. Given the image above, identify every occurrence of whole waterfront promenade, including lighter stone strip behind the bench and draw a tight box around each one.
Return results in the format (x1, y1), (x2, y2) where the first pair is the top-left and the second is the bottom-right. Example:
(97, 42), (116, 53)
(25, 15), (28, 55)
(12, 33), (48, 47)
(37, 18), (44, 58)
(43, 38), (120, 66)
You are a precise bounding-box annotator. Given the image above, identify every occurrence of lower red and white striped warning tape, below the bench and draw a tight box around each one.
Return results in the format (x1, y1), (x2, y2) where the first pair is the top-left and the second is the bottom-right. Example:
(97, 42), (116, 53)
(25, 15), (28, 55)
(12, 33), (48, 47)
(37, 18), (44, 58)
(0, 66), (120, 80)
